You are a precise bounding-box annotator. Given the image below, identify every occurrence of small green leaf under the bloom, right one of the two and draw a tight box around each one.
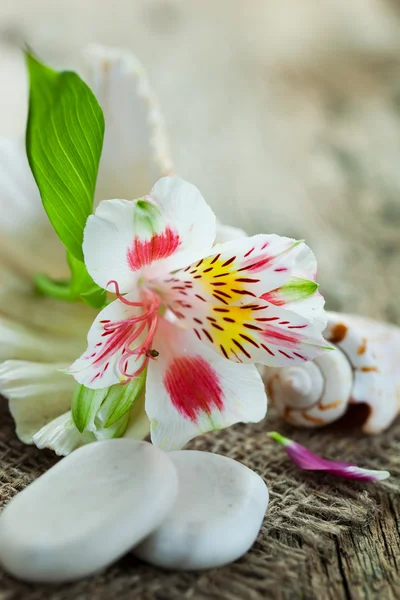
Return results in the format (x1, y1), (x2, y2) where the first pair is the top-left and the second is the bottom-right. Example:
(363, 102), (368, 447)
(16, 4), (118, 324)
(98, 369), (146, 428)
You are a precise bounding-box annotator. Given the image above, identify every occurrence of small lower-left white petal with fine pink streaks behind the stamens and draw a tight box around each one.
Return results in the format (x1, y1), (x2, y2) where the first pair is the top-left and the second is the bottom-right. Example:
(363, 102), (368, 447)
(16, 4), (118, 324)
(67, 294), (146, 389)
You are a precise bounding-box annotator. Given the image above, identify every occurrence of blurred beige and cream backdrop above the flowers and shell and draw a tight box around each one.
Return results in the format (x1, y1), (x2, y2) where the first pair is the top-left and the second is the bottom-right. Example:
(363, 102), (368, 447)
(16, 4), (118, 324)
(0, 0), (400, 324)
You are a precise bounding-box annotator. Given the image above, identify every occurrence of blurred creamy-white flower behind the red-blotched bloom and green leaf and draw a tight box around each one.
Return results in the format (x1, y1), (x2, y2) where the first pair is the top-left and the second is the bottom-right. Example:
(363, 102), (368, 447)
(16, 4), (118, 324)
(0, 46), (173, 454)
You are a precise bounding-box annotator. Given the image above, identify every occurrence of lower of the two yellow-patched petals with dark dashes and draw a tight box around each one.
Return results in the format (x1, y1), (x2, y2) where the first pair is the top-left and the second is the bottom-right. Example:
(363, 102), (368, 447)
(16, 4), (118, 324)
(152, 284), (330, 367)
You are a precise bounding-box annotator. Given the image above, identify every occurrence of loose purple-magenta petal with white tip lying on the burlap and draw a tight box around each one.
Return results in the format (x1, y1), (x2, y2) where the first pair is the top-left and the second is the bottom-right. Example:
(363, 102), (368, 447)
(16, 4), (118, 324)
(268, 431), (390, 481)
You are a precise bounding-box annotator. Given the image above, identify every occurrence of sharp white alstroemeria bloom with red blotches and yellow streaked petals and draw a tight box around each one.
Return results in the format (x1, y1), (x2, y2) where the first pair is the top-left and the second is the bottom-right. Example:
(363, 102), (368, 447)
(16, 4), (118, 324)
(69, 177), (326, 448)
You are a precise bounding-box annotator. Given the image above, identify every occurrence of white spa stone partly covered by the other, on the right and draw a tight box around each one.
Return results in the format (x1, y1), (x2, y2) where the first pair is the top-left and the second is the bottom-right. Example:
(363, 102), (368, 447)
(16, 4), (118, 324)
(133, 450), (268, 570)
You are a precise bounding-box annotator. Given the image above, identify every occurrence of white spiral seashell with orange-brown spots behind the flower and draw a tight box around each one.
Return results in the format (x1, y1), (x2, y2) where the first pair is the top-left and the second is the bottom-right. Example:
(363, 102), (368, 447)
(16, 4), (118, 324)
(263, 312), (400, 433)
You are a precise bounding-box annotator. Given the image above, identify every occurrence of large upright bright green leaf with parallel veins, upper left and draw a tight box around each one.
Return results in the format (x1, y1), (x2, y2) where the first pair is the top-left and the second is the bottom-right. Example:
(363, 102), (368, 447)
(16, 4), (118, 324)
(26, 53), (104, 260)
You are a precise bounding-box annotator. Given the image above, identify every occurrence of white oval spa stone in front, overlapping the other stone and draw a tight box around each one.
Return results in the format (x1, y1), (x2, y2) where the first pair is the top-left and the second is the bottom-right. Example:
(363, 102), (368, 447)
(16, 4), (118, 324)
(0, 439), (178, 583)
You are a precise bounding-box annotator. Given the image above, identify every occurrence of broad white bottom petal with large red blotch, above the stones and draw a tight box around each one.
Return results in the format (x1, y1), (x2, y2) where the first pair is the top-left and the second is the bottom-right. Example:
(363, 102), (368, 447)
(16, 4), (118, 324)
(146, 319), (267, 450)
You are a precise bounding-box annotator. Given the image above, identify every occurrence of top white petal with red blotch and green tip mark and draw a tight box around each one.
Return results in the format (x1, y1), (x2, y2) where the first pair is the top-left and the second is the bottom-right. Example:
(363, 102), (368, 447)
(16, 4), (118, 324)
(83, 177), (216, 293)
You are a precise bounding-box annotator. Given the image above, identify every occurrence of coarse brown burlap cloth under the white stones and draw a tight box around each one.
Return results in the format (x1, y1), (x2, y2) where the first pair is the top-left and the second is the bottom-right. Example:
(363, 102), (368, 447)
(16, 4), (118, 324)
(0, 394), (400, 600)
